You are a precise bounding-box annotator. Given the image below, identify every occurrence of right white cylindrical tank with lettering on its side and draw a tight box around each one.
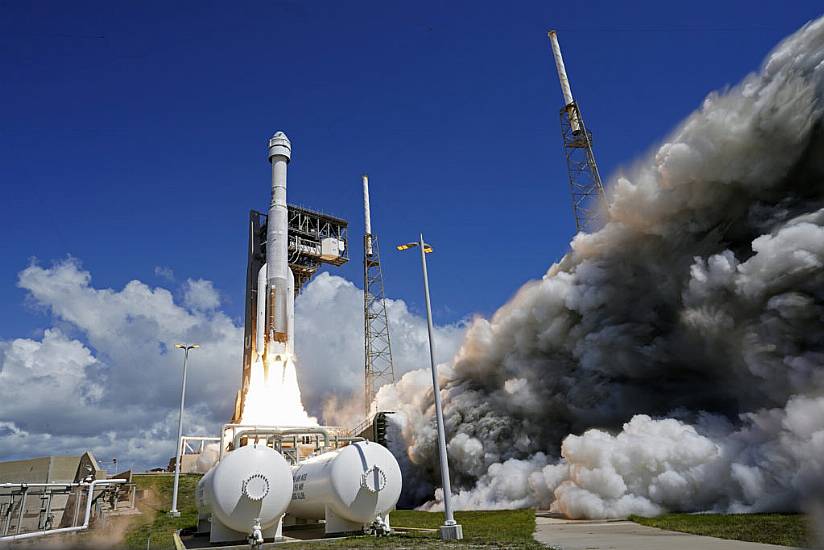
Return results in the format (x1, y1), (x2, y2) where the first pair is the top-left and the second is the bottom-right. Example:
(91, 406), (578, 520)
(288, 441), (402, 534)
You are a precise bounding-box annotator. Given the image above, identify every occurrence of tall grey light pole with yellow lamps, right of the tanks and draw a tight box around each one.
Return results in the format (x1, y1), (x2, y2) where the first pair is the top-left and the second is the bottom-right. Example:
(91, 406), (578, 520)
(398, 233), (463, 540)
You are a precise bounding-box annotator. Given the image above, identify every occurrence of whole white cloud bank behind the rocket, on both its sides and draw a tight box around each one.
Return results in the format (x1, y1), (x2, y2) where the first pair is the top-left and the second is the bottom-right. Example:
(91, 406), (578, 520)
(0, 258), (460, 468)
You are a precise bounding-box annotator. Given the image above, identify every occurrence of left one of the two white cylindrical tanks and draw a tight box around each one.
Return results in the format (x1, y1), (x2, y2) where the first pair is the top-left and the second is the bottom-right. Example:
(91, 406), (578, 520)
(196, 444), (292, 533)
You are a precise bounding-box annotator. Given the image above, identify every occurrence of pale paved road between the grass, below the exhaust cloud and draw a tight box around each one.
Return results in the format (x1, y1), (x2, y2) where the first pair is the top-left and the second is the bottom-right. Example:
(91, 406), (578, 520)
(535, 516), (800, 550)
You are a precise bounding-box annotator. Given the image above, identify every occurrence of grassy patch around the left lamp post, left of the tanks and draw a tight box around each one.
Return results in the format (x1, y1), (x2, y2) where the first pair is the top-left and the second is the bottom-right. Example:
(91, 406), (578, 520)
(125, 474), (200, 550)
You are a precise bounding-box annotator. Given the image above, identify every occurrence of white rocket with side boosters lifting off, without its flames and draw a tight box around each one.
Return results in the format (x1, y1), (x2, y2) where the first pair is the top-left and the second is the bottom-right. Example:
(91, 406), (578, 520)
(255, 132), (295, 361)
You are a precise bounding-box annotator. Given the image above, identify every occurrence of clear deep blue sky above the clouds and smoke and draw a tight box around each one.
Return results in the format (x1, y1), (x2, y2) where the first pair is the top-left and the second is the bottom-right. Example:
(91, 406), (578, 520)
(0, 1), (821, 339)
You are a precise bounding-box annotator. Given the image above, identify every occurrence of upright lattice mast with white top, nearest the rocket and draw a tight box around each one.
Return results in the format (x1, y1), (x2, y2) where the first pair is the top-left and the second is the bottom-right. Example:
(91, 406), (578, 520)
(363, 174), (395, 418)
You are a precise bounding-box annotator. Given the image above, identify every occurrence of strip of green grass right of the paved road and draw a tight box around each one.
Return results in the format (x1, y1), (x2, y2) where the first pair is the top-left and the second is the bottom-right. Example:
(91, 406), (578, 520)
(630, 514), (809, 547)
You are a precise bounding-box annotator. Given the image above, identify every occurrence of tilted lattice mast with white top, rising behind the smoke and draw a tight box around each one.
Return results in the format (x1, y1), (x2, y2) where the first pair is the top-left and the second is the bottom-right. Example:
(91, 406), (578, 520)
(548, 31), (607, 233)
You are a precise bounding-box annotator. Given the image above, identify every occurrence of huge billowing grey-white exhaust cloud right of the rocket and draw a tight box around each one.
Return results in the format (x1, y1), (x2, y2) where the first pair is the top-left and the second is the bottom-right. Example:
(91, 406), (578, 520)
(378, 19), (824, 518)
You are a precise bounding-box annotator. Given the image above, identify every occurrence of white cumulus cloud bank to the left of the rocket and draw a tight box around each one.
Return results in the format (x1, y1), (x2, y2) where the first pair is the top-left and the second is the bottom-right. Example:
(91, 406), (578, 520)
(0, 258), (242, 467)
